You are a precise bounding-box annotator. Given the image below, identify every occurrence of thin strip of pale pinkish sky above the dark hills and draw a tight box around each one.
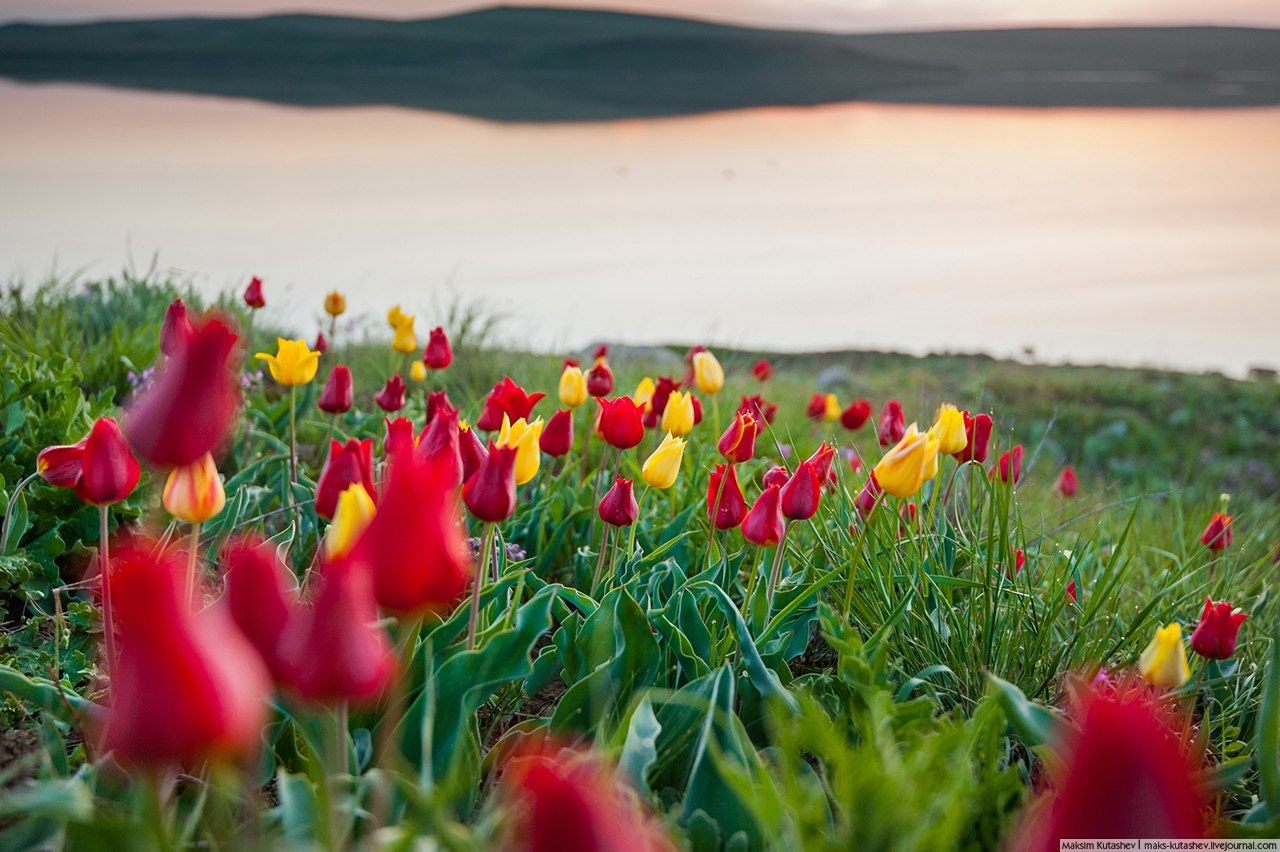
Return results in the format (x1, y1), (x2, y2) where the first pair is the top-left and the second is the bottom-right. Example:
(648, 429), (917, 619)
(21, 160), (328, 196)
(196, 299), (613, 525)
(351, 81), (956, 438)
(0, 0), (1280, 31)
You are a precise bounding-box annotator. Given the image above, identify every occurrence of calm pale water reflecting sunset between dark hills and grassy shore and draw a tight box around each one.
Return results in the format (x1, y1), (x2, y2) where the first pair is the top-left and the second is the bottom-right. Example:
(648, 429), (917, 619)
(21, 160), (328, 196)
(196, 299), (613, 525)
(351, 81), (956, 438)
(0, 82), (1280, 374)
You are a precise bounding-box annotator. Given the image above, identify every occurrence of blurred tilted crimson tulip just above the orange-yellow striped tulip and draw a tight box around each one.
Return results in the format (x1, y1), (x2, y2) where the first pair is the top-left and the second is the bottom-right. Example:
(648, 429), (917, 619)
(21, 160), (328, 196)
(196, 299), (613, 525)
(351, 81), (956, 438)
(124, 316), (239, 467)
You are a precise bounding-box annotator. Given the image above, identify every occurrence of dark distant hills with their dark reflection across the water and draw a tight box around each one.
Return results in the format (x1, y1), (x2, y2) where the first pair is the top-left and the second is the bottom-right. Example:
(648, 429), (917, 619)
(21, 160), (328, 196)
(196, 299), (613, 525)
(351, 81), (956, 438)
(0, 9), (1280, 122)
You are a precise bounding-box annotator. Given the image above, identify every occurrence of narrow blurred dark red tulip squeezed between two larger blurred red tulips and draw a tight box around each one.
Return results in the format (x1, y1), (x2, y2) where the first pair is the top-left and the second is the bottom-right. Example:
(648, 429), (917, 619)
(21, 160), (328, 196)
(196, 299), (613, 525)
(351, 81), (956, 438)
(221, 533), (296, 683)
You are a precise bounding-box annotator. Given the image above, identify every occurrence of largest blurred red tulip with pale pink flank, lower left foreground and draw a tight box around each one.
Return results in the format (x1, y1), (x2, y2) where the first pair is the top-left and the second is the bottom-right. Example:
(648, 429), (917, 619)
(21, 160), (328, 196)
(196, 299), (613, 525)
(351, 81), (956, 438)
(102, 541), (270, 769)
